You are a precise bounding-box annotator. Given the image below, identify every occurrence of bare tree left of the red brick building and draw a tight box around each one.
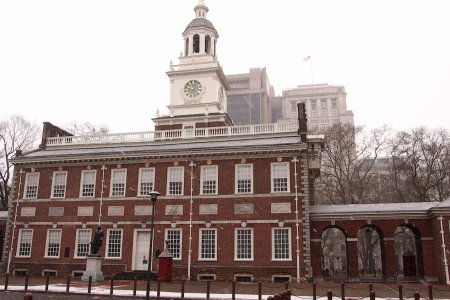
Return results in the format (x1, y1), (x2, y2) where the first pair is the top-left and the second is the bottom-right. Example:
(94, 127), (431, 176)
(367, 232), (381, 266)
(0, 115), (39, 210)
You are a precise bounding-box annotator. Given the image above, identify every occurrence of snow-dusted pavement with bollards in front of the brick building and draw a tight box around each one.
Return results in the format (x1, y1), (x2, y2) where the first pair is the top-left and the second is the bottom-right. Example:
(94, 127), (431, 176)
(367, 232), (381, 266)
(0, 276), (450, 300)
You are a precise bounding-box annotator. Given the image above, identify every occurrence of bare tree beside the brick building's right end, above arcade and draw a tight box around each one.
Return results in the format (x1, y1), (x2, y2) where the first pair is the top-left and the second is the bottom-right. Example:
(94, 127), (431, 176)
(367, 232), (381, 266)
(316, 123), (389, 204)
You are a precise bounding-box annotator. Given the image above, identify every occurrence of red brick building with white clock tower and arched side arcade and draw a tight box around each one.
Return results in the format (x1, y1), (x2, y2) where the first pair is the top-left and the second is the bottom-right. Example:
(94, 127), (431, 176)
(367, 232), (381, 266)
(3, 1), (450, 283)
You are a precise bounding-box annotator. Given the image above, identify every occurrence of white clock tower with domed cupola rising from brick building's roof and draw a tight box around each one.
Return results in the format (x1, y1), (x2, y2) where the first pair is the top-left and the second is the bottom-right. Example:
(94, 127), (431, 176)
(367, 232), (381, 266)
(153, 0), (232, 130)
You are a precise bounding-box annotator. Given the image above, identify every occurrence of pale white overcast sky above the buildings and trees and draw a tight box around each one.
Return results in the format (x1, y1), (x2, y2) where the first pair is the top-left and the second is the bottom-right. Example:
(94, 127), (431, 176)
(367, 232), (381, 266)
(0, 0), (450, 132)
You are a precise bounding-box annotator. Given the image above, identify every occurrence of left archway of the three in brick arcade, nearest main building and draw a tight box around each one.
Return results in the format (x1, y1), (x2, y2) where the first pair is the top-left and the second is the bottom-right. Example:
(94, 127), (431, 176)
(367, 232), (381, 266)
(321, 226), (347, 277)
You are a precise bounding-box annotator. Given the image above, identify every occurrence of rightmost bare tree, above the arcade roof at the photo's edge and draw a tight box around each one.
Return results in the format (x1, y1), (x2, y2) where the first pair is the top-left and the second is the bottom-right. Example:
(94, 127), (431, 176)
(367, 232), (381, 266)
(389, 127), (450, 202)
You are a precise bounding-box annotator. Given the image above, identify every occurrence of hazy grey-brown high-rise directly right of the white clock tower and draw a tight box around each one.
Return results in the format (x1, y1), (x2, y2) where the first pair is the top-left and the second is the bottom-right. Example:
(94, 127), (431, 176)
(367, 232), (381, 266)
(227, 68), (275, 125)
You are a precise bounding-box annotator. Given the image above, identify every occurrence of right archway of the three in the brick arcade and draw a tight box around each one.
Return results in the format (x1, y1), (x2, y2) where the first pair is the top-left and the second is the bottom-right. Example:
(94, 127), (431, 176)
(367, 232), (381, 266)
(394, 224), (423, 277)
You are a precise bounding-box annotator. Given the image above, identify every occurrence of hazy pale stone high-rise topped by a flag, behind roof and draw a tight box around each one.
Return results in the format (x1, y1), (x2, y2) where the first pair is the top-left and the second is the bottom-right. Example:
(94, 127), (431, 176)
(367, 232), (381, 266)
(277, 84), (354, 131)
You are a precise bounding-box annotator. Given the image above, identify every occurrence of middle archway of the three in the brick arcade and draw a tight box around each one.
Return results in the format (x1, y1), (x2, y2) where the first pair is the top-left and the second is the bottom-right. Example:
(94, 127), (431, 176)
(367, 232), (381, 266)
(357, 224), (384, 277)
